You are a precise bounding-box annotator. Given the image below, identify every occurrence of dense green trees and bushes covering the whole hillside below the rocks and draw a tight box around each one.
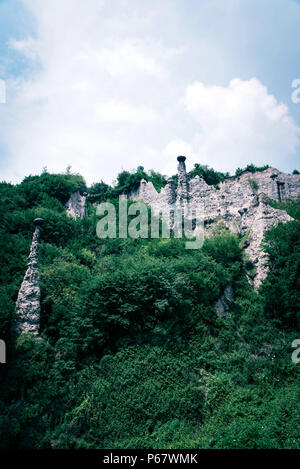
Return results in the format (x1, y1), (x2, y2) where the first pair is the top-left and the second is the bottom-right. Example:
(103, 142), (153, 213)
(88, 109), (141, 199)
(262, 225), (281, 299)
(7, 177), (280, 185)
(0, 168), (300, 448)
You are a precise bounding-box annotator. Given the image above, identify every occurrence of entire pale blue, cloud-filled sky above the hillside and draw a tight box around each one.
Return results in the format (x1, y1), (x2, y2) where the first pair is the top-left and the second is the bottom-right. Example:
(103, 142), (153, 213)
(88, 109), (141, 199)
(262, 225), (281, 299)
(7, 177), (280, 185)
(0, 0), (300, 184)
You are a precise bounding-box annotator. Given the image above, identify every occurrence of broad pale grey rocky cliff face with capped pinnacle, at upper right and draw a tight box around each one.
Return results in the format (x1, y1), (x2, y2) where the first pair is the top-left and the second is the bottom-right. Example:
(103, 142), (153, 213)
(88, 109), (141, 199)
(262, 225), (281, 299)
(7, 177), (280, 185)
(131, 157), (300, 288)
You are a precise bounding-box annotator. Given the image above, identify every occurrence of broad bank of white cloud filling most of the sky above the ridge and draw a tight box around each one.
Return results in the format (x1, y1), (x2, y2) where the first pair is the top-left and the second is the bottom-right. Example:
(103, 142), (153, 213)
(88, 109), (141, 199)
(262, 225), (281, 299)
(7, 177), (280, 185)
(0, 0), (299, 183)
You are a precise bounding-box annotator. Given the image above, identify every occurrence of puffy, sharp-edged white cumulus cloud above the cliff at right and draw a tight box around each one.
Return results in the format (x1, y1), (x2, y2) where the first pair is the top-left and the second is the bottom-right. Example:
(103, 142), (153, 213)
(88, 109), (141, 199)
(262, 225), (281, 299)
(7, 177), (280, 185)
(166, 78), (300, 175)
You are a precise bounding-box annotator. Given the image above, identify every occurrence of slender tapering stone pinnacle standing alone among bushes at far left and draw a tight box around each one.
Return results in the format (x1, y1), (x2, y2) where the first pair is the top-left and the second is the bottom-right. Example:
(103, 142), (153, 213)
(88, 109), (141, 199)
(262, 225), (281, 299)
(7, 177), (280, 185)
(14, 218), (44, 335)
